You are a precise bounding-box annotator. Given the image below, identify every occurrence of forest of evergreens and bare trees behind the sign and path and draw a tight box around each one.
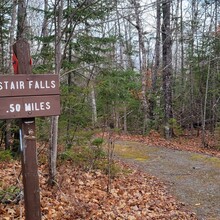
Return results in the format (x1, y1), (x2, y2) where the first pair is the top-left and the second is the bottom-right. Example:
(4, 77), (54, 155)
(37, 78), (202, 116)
(0, 0), (220, 219)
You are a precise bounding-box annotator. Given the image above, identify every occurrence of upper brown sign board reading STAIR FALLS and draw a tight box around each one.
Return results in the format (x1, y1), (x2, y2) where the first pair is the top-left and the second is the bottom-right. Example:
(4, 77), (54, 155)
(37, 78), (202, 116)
(0, 74), (60, 97)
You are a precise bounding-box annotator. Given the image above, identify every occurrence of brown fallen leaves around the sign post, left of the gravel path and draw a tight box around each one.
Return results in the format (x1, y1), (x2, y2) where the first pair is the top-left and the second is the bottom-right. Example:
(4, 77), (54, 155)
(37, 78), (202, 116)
(0, 159), (197, 220)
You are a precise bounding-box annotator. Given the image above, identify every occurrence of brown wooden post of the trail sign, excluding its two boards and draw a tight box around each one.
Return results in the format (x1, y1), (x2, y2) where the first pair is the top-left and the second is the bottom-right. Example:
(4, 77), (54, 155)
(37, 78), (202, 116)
(13, 39), (41, 220)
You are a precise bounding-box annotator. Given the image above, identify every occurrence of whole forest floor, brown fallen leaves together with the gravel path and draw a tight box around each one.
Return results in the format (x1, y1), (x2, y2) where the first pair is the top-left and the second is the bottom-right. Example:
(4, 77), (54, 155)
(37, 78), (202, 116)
(0, 132), (220, 220)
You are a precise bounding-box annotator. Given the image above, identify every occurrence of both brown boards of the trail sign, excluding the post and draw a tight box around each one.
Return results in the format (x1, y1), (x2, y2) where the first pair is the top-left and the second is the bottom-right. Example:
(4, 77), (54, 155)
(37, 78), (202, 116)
(0, 74), (60, 119)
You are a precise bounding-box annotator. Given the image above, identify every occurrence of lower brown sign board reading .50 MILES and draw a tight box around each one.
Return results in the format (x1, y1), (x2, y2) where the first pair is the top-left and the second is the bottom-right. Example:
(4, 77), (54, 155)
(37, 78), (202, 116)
(0, 95), (60, 119)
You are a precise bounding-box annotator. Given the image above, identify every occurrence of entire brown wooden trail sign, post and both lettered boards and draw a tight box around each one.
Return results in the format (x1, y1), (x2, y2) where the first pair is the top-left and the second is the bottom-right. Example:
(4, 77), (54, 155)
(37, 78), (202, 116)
(0, 39), (60, 220)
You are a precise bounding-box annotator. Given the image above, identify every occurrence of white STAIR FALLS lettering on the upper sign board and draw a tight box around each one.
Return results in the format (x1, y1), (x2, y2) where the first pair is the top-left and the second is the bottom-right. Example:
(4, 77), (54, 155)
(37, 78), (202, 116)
(0, 80), (56, 90)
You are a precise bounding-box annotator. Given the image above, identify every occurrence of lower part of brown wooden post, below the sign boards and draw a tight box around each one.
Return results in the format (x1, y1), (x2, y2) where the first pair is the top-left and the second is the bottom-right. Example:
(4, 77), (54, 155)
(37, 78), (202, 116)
(20, 118), (41, 220)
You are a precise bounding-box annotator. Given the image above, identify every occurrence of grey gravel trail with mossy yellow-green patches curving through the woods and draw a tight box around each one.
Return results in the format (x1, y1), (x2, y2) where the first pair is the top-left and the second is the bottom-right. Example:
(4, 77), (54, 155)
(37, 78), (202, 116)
(115, 141), (220, 220)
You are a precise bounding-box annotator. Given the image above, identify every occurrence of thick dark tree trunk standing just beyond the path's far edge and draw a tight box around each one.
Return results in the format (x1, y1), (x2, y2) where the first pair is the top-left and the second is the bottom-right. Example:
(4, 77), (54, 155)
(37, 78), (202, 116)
(162, 0), (173, 139)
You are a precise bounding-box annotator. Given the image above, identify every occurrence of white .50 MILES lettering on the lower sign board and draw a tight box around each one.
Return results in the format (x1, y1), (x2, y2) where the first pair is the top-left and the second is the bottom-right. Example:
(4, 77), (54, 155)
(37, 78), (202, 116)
(6, 102), (51, 113)
